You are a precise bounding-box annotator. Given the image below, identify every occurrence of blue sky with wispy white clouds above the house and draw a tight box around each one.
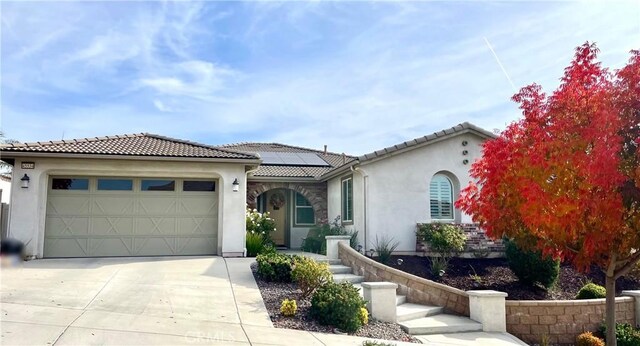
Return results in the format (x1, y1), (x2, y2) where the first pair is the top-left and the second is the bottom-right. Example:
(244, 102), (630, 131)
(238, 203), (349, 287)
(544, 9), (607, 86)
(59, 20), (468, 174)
(0, 1), (640, 154)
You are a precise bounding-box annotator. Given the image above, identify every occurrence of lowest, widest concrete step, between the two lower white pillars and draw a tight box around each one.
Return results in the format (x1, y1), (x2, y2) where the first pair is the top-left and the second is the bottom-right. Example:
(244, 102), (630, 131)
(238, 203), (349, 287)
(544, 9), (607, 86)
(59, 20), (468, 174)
(398, 314), (482, 335)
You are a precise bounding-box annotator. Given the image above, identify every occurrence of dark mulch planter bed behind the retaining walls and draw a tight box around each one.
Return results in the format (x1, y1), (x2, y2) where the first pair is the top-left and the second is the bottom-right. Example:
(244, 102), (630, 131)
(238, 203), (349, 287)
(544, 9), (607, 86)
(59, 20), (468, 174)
(389, 256), (640, 300)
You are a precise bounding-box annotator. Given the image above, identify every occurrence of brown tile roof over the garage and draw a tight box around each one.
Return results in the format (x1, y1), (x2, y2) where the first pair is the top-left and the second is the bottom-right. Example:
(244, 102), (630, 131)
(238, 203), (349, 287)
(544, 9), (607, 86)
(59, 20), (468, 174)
(0, 133), (258, 159)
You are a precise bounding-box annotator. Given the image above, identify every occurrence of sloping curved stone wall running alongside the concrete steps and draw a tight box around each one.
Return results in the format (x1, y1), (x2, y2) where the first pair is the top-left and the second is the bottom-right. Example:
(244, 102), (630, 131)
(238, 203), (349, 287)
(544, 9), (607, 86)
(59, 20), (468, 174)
(338, 243), (469, 316)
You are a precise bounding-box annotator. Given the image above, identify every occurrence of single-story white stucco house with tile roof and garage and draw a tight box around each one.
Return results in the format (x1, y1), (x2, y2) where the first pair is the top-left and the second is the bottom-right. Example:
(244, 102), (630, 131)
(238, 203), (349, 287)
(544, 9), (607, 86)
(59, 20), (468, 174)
(0, 123), (494, 258)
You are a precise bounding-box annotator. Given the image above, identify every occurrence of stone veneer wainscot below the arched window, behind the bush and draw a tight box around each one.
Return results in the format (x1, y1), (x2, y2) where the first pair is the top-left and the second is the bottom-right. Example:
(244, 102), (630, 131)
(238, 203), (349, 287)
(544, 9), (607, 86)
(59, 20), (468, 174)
(416, 223), (504, 258)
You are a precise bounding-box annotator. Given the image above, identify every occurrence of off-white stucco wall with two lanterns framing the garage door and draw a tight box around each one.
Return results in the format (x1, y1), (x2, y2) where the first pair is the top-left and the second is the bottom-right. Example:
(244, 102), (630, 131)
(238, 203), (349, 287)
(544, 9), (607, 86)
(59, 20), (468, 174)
(9, 157), (246, 257)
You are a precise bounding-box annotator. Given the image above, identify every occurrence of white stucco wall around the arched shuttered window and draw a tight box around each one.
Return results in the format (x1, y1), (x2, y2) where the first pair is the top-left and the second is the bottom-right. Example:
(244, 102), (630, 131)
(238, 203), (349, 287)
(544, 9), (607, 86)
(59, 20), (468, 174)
(328, 133), (484, 252)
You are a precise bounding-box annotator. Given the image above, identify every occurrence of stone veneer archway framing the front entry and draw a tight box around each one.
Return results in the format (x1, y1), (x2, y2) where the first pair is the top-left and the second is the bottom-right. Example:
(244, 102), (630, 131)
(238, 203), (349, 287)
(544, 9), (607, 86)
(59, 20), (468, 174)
(247, 181), (329, 224)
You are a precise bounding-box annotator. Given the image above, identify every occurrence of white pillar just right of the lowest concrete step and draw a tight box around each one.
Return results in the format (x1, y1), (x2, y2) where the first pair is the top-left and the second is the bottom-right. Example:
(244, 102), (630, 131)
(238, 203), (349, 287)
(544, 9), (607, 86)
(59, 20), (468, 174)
(467, 290), (507, 332)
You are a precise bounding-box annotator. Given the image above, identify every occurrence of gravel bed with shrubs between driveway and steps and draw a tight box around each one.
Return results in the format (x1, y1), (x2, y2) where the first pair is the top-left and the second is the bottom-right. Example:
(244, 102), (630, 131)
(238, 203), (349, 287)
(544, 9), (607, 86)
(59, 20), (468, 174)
(251, 263), (420, 343)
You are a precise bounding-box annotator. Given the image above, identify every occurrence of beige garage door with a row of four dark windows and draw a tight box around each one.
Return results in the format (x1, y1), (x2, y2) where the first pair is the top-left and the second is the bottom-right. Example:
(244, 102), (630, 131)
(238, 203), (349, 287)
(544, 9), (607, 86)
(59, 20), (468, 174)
(44, 177), (218, 257)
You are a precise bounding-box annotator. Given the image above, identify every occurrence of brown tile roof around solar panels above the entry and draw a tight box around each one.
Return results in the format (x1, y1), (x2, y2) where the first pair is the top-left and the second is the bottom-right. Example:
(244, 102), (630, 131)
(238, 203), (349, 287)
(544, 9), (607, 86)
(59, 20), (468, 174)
(219, 142), (356, 178)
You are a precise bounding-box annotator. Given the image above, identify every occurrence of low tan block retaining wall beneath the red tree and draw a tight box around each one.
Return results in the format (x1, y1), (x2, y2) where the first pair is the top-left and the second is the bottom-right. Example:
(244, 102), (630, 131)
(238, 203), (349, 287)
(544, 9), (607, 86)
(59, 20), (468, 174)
(506, 297), (635, 345)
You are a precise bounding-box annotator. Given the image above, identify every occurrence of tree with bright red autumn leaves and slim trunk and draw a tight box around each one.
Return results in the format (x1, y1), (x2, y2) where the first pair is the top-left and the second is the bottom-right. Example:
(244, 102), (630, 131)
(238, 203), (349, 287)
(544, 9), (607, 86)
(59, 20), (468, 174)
(456, 42), (640, 345)
